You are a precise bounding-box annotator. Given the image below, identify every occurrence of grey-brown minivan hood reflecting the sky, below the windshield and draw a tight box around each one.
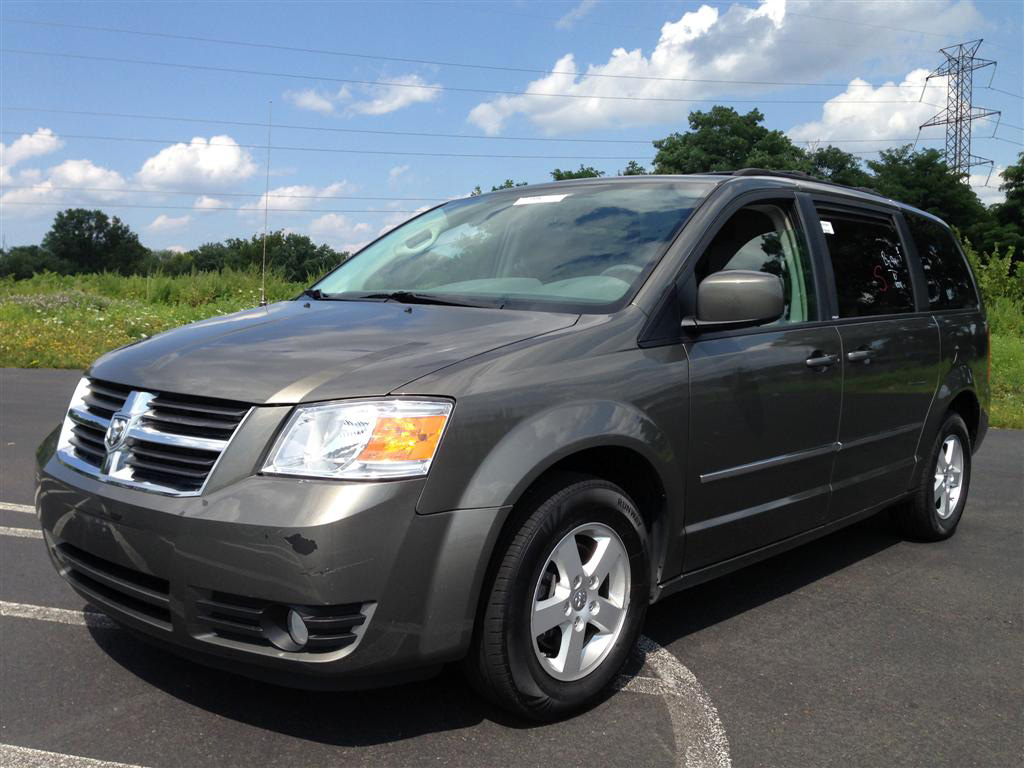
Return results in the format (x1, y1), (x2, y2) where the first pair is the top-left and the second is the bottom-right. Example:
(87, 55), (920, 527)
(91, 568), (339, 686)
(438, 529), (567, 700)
(89, 301), (579, 403)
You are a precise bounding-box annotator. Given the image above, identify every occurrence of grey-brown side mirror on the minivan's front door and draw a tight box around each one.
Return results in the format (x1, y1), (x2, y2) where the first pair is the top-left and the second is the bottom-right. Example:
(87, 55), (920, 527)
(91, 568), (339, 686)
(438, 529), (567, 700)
(683, 269), (785, 331)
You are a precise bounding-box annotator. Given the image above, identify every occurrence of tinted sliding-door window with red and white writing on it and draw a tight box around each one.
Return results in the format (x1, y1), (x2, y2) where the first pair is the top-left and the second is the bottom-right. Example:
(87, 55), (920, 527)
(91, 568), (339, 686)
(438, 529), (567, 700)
(818, 208), (914, 317)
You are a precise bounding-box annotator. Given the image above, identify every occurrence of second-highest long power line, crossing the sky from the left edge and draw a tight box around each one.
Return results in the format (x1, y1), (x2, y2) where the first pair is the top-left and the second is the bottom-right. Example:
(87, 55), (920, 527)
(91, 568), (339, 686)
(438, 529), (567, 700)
(0, 48), (938, 106)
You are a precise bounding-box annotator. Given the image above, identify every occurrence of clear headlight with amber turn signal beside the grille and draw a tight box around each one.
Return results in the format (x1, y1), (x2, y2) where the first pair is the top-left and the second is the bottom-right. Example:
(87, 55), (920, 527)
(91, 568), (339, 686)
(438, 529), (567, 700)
(263, 399), (452, 480)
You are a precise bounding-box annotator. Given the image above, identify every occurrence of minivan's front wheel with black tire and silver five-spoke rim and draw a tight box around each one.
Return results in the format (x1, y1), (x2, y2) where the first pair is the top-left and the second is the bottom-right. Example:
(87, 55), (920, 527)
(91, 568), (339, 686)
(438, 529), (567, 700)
(467, 474), (650, 721)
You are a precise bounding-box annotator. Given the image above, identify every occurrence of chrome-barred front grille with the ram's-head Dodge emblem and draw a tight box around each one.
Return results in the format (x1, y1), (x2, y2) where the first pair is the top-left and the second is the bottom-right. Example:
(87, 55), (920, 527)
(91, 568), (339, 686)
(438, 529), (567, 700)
(57, 379), (250, 496)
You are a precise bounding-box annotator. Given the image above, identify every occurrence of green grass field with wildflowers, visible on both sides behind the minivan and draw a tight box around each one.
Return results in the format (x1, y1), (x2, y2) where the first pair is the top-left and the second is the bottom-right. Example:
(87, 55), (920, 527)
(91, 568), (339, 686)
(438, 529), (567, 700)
(0, 270), (1024, 429)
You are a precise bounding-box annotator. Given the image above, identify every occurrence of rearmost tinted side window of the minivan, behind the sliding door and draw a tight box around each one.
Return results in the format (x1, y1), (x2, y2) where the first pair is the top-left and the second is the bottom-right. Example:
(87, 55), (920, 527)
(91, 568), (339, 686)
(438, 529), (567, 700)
(905, 213), (978, 309)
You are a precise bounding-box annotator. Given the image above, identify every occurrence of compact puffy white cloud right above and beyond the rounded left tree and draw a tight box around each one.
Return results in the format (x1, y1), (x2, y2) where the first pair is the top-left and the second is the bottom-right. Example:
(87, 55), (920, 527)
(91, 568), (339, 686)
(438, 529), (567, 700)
(138, 135), (259, 186)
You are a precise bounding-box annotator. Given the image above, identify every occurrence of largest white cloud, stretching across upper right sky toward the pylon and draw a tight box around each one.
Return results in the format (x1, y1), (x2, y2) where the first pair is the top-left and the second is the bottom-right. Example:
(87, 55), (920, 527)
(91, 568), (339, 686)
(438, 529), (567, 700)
(468, 0), (982, 135)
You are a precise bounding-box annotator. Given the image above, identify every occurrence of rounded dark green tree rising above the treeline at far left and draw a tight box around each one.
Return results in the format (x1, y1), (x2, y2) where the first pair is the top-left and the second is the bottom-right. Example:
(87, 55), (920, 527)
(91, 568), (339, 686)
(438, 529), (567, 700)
(43, 208), (150, 274)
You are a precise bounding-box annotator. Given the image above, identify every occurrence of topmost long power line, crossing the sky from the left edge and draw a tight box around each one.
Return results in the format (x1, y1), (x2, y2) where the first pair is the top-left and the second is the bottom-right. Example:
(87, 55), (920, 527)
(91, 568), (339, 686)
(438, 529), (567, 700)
(2, 16), (942, 89)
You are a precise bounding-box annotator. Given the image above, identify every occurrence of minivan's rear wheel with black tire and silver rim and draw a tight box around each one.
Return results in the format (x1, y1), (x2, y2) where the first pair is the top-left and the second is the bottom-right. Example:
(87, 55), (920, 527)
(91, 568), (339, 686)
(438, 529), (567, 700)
(895, 414), (971, 542)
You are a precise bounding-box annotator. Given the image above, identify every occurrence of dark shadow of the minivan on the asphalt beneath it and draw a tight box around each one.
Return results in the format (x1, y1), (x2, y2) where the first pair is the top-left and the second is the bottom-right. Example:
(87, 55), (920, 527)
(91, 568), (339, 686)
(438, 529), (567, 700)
(90, 516), (900, 746)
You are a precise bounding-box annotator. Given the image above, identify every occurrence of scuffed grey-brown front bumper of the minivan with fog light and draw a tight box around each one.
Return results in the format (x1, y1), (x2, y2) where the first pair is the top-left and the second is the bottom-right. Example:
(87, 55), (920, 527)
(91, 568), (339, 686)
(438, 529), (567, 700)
(36, 440), (508, 688)
